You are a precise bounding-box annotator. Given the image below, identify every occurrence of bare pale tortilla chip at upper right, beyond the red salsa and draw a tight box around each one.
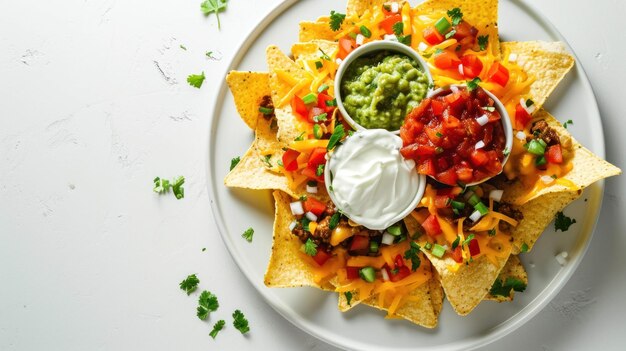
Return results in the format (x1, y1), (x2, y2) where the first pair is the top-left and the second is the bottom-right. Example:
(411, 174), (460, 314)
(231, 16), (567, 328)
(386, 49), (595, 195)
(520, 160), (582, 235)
(500, 41), (575, 109)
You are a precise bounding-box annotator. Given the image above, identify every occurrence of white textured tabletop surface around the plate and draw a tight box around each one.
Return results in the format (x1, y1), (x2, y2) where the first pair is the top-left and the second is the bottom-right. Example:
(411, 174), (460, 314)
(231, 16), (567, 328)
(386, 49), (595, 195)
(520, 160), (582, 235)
(0, 0), (626, 350)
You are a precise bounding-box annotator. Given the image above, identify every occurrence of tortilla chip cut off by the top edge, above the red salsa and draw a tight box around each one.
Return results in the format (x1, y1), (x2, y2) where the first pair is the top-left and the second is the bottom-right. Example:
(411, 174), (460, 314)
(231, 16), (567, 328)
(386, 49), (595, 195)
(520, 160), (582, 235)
(415, 0), (500, 59)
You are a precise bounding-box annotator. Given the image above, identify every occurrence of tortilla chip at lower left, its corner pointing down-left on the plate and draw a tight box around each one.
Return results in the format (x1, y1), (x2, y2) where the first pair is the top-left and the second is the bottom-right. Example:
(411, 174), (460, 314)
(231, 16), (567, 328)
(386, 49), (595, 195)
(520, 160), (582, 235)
(265, 191), (335, 291)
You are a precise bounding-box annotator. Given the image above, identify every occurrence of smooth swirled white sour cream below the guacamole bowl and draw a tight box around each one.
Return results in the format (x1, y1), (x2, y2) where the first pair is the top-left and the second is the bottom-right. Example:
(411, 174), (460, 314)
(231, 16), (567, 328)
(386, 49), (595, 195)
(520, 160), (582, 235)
(325, 129), (426, 230)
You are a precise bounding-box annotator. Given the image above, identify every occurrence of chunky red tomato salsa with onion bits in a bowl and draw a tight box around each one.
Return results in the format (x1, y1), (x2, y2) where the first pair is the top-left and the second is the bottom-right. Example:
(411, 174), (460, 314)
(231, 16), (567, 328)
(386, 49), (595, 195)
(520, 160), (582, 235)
(400, 87), (506, 185)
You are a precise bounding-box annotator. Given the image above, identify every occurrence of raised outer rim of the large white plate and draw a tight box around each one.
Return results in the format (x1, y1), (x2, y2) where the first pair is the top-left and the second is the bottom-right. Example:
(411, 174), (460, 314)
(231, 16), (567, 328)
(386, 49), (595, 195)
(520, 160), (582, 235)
(204, 0), (605, 350)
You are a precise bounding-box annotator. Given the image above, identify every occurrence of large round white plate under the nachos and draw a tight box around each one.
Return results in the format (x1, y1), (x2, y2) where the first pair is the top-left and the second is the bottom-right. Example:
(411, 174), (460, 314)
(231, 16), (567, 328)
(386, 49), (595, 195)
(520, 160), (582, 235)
(207, 0), (604, 350)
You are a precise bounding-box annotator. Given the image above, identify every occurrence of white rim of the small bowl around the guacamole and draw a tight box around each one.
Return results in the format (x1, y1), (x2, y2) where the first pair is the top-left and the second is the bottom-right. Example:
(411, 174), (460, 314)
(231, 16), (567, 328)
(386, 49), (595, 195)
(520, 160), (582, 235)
(335, 40), (433, 134)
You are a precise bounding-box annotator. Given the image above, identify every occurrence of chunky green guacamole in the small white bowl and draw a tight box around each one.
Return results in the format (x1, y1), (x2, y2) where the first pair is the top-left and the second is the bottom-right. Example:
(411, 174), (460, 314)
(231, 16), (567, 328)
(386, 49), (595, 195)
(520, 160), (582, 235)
(341, 51), (428, 131)
